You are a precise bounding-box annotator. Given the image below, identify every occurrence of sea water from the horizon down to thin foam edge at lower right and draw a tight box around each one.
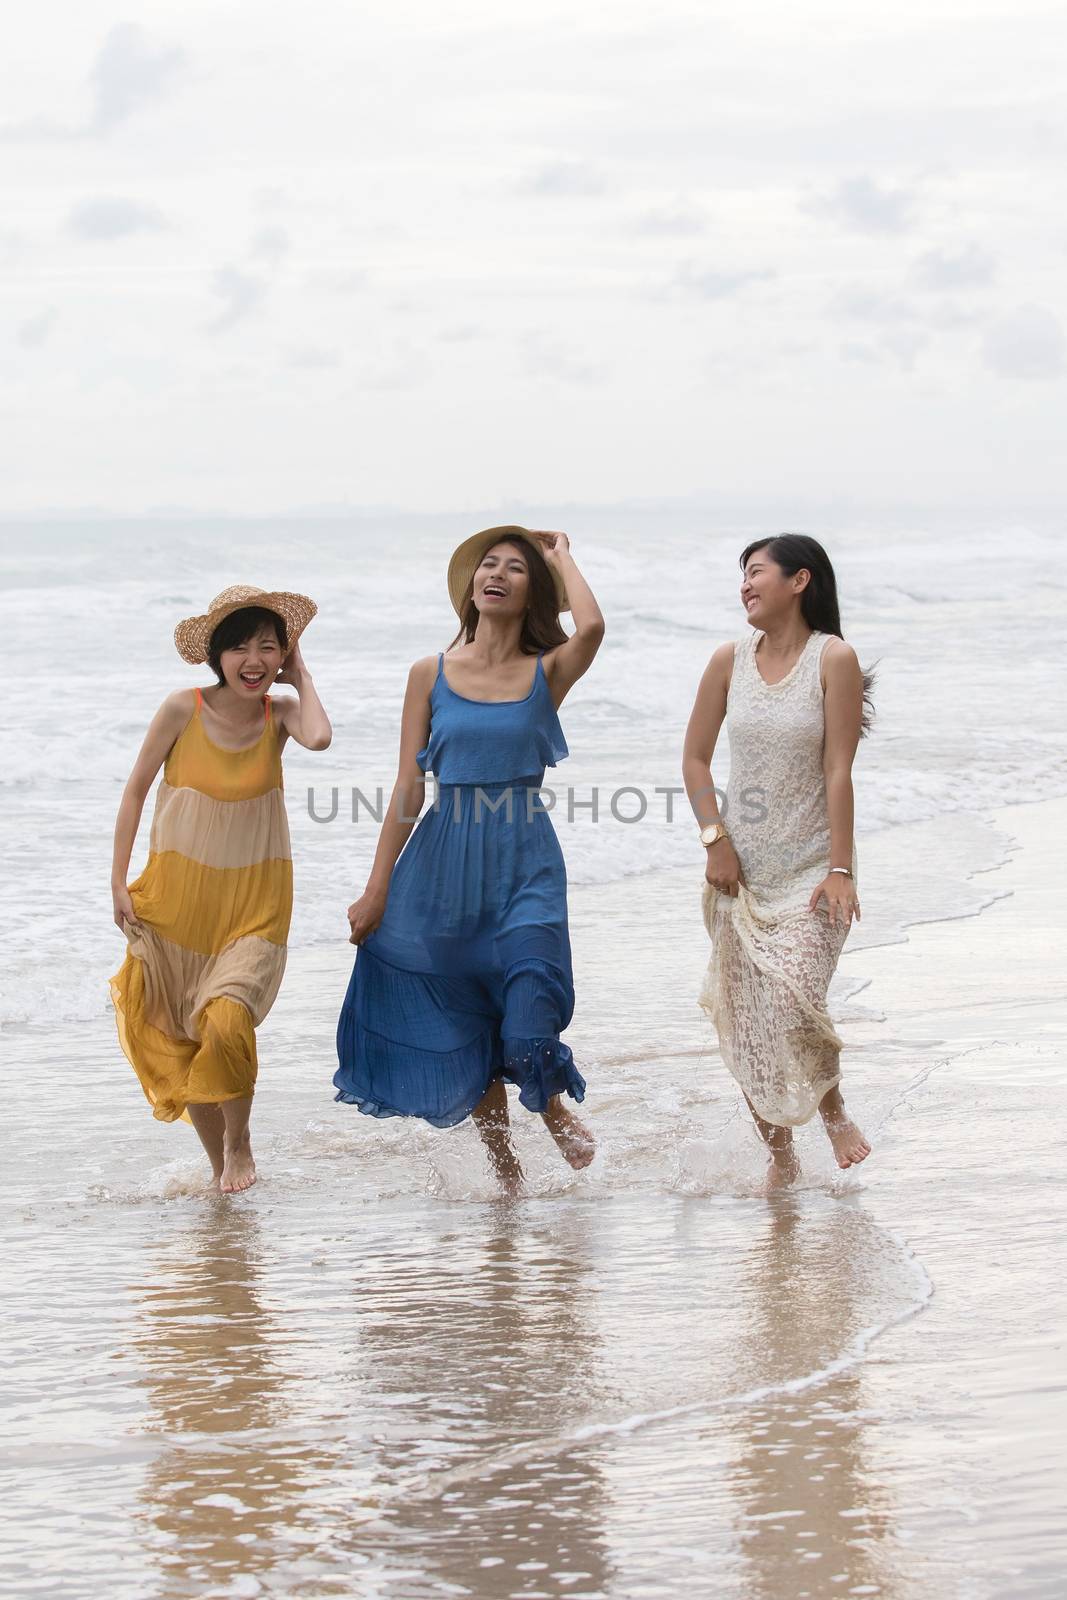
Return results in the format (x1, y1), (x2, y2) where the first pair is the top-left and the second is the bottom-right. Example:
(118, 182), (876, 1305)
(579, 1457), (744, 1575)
(0, 512), (1067, 1600)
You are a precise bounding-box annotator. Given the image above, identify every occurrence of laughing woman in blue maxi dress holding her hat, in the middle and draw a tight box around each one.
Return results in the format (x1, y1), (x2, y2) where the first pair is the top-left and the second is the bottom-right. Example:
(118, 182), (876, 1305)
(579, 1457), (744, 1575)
(334, 526), (605, 1194)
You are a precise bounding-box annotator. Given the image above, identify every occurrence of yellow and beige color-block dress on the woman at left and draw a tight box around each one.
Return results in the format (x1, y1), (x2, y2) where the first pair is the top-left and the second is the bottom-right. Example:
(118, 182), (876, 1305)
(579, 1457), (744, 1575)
(110, 690), (293, 1122)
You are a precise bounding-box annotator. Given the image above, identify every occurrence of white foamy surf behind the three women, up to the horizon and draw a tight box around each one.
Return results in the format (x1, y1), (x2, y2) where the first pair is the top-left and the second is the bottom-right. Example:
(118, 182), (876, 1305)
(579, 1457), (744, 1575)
(0, 514), (1067, 1026)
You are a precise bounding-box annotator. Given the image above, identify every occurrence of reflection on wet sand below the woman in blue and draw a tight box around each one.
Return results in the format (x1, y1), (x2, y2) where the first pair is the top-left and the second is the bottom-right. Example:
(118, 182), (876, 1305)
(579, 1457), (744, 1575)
(348, 1203), (611, 1600)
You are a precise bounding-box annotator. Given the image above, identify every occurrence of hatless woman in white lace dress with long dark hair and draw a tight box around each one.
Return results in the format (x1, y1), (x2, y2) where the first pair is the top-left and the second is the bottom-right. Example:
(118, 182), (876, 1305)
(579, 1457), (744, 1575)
(683, 534), (870, 1189)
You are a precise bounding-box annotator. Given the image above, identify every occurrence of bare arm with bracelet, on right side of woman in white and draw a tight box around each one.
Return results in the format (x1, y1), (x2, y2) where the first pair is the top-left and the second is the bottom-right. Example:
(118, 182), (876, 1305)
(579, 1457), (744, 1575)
(811, 640), (864, 926)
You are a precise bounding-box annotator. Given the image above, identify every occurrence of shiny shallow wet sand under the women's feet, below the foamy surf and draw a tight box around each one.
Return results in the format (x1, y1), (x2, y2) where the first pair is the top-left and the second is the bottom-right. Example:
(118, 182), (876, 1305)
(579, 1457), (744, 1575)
(0, 802), (1067, 1600)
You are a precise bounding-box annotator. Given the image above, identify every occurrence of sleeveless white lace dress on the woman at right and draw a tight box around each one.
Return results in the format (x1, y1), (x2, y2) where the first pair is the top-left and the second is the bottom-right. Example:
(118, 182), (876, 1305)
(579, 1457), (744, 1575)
(699, 629), (856, 1126)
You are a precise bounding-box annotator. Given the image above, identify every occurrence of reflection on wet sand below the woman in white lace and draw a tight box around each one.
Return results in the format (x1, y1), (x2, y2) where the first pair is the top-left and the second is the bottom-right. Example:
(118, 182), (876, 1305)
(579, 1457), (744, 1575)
(731, 1197), (913, 1600)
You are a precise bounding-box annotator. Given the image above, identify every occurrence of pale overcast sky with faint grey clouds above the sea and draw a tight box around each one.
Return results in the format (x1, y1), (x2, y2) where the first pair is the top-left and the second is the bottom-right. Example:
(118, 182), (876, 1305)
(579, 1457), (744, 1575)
(0, 0), (1067, 520)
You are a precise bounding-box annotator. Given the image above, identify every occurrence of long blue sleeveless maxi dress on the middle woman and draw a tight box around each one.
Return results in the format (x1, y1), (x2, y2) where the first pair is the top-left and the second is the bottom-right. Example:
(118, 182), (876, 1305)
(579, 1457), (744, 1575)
(333, 654), (585, 1128)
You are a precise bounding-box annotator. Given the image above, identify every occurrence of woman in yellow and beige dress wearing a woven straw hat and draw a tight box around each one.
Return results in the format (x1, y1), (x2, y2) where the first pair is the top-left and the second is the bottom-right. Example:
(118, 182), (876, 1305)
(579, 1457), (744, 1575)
(110, 584), (331, 1194)
